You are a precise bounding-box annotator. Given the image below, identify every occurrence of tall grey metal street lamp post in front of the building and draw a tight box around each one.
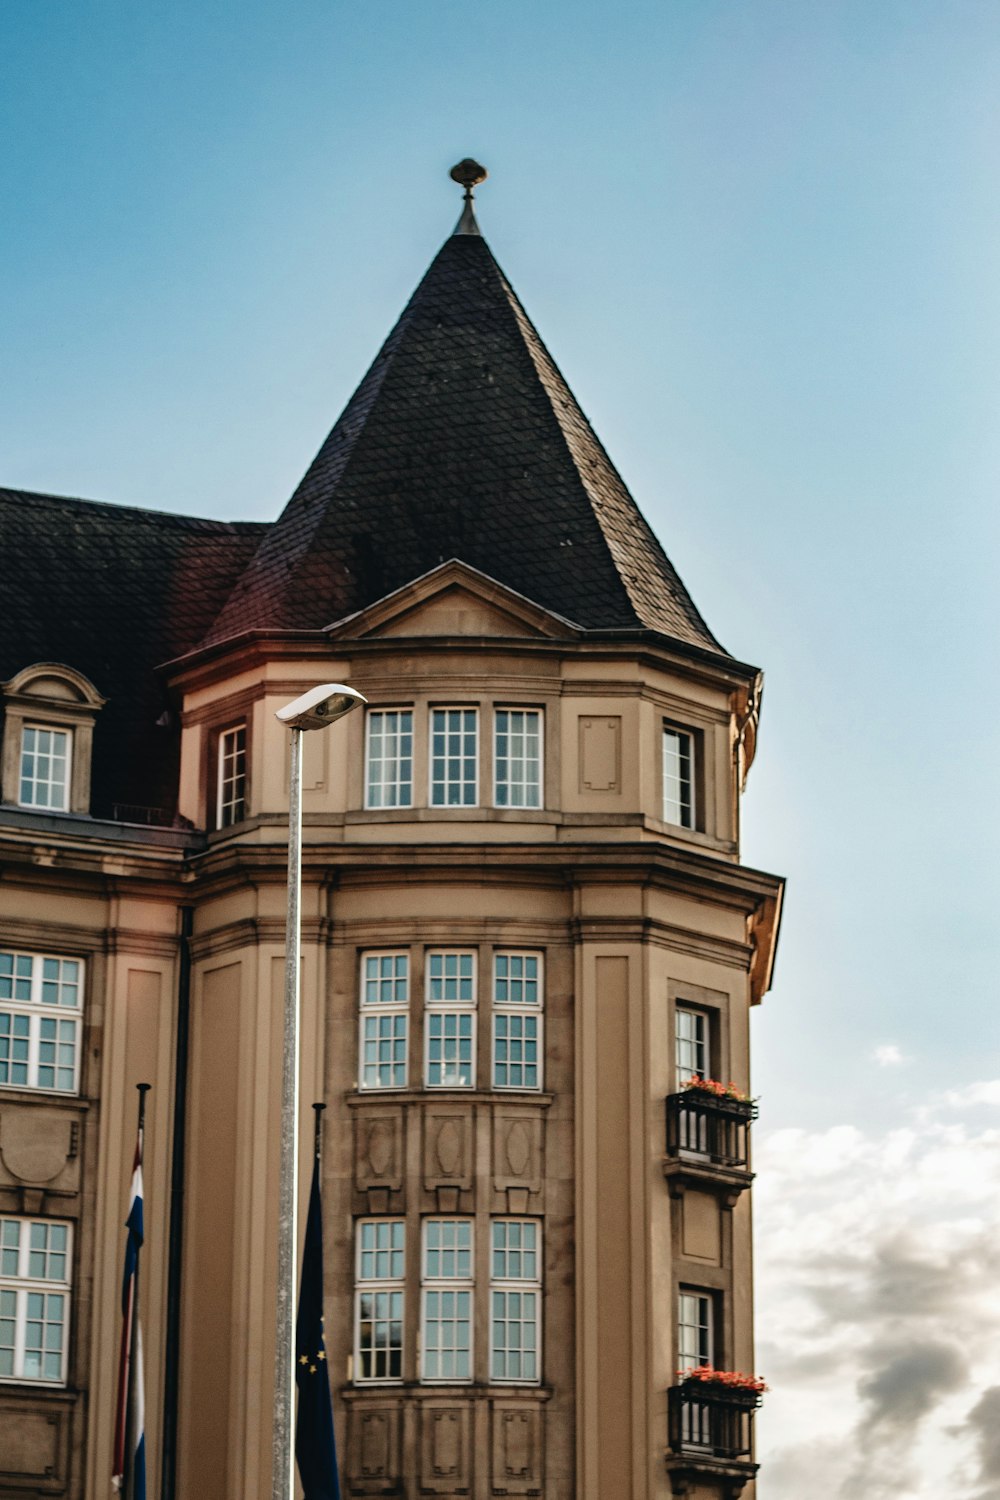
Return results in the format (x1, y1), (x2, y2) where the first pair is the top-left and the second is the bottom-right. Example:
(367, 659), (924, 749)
(271, 683), (366, 1500)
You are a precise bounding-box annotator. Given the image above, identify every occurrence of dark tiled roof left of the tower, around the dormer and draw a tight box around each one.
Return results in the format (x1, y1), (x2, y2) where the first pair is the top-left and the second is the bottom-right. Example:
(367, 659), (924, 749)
(0, 489), (267, 818)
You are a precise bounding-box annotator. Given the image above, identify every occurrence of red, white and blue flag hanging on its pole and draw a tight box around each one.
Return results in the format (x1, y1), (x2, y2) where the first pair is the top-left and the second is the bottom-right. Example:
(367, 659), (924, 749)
(111, 1083), (148, 1500)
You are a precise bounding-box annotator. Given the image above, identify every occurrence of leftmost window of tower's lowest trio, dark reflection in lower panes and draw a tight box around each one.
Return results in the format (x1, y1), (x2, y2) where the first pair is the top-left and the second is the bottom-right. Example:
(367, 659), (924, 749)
(354, 1220), (406, 1382)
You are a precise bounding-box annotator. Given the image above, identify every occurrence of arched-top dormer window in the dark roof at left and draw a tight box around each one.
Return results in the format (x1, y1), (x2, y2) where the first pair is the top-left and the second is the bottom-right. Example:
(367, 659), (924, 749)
(1, 662), (105, 813)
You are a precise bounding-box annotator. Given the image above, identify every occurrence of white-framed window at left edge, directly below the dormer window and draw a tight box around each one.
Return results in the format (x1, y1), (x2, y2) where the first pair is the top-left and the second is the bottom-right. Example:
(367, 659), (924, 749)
(0, 948), (84, 1094)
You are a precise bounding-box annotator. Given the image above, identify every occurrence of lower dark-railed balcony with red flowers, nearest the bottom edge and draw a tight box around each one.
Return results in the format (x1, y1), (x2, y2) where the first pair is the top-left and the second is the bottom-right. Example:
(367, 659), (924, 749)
(667, 1380), (760, 1500)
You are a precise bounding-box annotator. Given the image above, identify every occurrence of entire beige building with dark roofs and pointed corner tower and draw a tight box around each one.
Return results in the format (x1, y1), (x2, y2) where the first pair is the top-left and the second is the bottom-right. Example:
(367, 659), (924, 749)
(0, 167), (781, 1500)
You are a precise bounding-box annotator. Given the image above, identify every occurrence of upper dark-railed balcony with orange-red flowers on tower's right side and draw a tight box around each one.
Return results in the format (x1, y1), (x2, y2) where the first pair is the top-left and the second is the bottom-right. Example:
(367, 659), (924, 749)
(663, 1088), (757, 1208)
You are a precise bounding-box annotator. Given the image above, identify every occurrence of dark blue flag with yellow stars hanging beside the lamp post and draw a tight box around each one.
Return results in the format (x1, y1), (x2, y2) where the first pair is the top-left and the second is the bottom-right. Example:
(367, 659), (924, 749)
(295, 1154), (340, 1500)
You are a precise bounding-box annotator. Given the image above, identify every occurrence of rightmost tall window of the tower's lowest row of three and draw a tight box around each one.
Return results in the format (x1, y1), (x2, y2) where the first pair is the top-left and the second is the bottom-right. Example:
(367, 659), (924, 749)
(490, 1220), (541, 1383)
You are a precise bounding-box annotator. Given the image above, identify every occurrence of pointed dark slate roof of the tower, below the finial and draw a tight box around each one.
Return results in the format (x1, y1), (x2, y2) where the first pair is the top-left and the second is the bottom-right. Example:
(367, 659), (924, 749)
(207, 207), (721, 651)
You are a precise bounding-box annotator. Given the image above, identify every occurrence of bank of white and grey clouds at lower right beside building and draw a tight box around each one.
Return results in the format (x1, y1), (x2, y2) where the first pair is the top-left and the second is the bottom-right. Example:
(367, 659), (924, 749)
(754, 1082), (1000, 1500)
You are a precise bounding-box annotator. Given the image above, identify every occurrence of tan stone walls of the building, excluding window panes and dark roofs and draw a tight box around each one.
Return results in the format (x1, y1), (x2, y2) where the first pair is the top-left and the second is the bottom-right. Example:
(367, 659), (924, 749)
(0, 187), (781, 1500)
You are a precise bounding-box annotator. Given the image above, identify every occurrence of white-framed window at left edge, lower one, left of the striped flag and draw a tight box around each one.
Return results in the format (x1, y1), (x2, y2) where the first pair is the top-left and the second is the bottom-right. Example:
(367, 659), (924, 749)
(0, 1218), (70, 1385)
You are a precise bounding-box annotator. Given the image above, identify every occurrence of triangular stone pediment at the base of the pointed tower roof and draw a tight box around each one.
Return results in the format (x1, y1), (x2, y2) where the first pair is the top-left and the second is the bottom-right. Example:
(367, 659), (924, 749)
(327, 558), (580, 641)
